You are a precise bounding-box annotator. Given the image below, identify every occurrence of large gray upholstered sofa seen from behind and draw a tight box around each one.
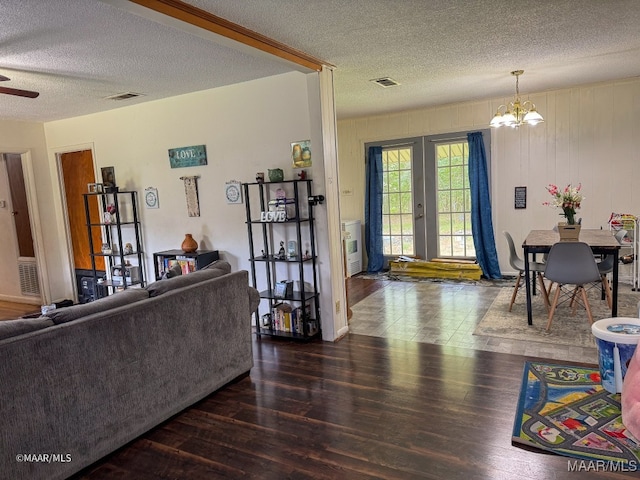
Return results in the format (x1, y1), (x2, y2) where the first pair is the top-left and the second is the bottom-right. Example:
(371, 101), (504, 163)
(0, 262), (260, 480)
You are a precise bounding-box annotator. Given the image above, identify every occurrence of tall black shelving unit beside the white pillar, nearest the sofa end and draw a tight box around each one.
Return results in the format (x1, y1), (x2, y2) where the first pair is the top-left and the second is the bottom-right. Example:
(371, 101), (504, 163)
(242, 179), (321, 340)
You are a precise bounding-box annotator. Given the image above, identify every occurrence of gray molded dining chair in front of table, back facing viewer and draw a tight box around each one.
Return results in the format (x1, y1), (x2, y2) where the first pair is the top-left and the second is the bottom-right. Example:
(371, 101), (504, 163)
(544, 242), (601, 331)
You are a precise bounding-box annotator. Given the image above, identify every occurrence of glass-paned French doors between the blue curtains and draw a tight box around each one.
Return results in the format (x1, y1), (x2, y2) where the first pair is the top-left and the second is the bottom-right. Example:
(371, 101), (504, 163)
(365, 132), (490, 261)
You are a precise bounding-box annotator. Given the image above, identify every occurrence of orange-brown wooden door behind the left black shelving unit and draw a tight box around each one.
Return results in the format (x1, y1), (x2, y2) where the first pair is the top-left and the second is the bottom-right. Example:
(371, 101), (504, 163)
(60, 150), (104, 270)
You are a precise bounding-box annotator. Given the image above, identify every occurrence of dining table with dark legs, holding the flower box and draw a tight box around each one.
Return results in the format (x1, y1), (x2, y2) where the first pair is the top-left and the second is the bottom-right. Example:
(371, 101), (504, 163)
(522, 228), (620, 325)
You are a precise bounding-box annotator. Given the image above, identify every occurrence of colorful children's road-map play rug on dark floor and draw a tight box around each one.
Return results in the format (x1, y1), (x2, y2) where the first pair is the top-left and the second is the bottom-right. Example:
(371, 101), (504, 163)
(512, 362), (640, 471)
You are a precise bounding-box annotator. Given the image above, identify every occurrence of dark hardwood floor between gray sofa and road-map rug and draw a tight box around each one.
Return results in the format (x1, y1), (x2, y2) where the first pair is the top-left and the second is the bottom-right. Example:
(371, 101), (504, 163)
(5, 277), (637, 480)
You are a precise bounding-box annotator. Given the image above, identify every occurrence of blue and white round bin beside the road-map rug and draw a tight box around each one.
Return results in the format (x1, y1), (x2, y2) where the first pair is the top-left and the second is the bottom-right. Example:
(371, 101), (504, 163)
(591, 317), (640, 393)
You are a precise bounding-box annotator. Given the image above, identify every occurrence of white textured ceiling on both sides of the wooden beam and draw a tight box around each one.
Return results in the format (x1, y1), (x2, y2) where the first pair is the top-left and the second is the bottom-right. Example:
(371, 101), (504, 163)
(0, 0), (640, 121)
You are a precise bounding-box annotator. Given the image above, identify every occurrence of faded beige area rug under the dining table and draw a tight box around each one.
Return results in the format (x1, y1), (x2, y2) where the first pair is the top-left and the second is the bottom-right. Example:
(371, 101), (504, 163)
(473, 287), (640, 348)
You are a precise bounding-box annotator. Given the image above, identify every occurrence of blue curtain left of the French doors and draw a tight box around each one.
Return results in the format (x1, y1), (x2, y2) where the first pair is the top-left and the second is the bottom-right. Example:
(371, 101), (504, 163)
(364, 147), (384, 273)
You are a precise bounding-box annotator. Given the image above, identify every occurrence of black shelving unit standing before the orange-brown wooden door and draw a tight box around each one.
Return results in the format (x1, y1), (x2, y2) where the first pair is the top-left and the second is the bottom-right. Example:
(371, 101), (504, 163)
(83, 191), (145, 299)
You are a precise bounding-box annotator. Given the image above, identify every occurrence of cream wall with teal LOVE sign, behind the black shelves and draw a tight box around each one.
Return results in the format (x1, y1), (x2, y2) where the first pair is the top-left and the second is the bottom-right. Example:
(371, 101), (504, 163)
(45, 72), (340, 338)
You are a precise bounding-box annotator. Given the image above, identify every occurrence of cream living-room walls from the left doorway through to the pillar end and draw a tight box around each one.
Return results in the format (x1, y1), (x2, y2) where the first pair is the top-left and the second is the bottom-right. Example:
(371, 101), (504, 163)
(0, 72), (346, 340)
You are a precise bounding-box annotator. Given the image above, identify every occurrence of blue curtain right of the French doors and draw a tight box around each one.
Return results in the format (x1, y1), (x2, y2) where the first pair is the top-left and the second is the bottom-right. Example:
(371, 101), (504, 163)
(467, 132), (502, 278)
